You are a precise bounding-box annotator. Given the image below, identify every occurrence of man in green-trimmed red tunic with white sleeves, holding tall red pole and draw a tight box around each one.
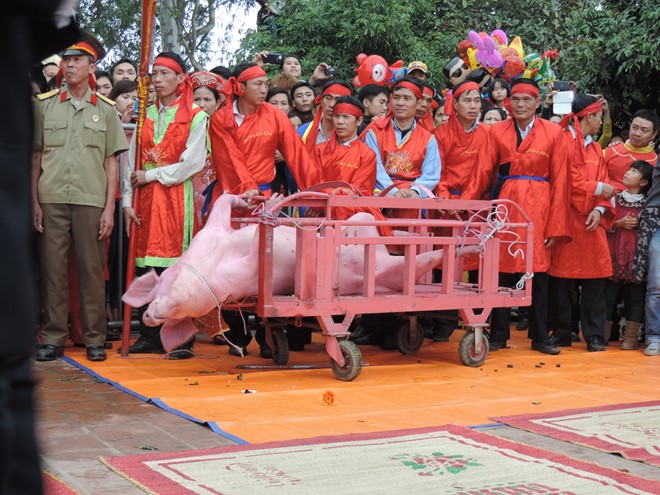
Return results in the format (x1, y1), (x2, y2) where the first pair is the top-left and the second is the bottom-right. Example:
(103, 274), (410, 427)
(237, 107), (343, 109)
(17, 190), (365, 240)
(122, 52), (207, 359)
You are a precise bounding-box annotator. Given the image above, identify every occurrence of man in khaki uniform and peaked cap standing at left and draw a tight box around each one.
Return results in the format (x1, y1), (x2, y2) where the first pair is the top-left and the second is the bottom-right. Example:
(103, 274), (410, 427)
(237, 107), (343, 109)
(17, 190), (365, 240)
(32, 34), (128, 361)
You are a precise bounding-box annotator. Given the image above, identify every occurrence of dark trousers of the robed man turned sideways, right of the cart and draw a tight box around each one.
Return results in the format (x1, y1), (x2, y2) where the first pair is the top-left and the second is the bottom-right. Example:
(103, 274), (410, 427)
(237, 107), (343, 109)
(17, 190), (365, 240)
(550, 277), (607, 342)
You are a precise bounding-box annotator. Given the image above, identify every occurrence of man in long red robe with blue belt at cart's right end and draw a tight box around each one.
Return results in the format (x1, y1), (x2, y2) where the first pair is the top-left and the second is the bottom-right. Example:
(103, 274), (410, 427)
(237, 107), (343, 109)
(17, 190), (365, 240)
(462, 78), (570, 354)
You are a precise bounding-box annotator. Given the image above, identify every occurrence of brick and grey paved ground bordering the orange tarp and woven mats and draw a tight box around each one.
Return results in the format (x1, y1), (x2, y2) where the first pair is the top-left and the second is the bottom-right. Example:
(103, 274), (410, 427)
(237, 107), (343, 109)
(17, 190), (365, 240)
(35, 348), (660, 495)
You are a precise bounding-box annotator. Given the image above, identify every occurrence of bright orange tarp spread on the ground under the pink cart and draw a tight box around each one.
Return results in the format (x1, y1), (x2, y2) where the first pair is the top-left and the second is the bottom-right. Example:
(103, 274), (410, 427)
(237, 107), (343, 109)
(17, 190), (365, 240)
(66, 330), (660, 443)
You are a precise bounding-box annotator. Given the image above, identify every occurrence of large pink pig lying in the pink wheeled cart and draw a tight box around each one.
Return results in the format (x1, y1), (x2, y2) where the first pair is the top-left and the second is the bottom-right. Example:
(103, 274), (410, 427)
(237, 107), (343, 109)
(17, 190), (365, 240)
(122, 194), (468, 351)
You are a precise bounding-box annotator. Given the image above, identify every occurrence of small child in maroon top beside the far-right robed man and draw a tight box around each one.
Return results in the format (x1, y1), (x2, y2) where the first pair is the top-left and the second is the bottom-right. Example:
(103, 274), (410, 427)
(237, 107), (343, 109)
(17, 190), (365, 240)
(605, 160), (653, 350)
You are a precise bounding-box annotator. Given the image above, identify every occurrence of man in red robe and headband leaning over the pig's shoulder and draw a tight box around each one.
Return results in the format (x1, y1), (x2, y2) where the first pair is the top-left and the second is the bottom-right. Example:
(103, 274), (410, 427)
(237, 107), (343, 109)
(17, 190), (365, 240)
(209, 64), (323, 201)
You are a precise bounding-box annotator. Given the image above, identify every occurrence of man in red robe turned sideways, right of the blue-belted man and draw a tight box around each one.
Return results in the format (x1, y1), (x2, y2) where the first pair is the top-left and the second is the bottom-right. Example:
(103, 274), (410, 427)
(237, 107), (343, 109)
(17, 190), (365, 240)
(548, 95), (616, 352)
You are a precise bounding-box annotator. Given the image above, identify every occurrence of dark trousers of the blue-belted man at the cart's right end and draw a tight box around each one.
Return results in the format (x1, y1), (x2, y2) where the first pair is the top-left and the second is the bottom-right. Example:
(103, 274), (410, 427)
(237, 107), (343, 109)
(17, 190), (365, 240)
(490, 272), (552, 343)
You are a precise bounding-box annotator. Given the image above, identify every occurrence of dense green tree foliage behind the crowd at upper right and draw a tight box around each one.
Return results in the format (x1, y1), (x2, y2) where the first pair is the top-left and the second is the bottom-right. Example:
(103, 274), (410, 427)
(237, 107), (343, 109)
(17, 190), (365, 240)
(236, 0), (660, 125)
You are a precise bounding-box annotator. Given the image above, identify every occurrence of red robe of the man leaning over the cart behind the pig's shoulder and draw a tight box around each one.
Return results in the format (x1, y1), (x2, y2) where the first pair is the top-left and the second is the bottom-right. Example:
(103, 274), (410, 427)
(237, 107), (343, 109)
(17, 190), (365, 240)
(209, 102), (323, 201)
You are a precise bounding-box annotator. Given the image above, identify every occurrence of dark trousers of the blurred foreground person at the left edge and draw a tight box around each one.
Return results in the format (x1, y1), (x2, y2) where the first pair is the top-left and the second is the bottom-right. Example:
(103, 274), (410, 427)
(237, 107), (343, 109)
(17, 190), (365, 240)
(0, 354), (42, 495)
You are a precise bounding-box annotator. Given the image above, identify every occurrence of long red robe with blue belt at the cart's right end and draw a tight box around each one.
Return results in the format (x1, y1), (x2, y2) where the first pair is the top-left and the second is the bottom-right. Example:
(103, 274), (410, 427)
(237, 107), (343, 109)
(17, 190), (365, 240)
(462, 117), (570, 273)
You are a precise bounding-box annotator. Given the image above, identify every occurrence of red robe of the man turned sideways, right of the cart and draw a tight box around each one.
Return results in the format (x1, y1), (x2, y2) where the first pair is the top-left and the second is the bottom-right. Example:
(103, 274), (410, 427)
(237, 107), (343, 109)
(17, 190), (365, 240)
(548, 129), (616, 278)
